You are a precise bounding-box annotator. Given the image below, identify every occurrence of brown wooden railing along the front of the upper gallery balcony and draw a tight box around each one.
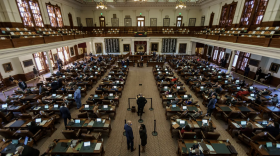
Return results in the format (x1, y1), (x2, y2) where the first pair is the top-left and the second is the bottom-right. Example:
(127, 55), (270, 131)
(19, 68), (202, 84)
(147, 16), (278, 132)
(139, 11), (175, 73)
(0, 32), (280, 49)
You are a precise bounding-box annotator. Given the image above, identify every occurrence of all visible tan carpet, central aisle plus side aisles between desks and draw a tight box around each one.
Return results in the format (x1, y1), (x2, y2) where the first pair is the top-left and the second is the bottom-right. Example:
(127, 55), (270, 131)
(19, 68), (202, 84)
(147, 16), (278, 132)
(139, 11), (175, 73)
(1, 64), (262, 156)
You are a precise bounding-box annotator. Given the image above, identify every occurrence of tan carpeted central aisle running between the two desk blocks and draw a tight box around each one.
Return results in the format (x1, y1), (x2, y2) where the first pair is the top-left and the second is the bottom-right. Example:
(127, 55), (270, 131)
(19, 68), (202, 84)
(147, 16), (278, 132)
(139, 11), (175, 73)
(105, 67), (177, 156)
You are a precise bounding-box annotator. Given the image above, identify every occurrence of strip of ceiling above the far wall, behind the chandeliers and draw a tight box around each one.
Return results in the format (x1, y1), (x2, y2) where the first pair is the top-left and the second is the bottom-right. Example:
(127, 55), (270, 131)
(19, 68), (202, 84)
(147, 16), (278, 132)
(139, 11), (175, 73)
(73, 0), (217, 9)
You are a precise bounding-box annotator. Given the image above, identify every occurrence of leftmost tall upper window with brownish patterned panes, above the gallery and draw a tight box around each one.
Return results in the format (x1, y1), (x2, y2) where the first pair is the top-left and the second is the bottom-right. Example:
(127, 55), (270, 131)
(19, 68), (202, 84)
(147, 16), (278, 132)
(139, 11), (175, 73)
(16, 0), (44, 27)
